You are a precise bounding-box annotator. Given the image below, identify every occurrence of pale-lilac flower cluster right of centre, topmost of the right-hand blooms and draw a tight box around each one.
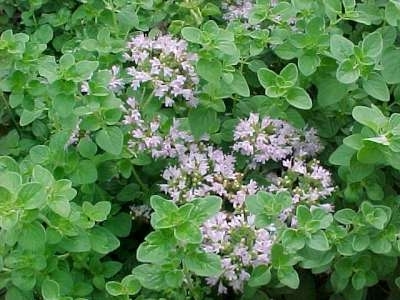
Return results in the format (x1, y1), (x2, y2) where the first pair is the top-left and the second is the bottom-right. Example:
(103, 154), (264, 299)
(233, 113), (321, 168)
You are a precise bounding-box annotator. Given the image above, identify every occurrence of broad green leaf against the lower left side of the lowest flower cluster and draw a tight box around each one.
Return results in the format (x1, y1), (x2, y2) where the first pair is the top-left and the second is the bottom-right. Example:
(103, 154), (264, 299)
(184, 252), (222, 277)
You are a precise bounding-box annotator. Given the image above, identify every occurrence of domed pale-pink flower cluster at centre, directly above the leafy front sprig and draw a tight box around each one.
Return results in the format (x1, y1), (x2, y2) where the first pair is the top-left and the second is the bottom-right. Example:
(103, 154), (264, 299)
(161, 144), (258, 208)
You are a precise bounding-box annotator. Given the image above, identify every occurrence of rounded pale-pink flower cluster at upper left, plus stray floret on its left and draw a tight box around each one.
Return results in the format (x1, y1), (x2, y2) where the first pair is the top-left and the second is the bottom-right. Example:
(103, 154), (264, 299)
(120, 34), (199, 107)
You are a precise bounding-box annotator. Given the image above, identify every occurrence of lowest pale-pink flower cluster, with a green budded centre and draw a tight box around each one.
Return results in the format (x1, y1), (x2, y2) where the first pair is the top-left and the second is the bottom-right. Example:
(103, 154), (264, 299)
(201, 212), (276, 294)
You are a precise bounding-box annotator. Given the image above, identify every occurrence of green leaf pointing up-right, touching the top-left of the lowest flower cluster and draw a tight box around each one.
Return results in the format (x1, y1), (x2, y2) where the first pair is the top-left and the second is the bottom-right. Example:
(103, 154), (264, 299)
(190, 196), (222, 225)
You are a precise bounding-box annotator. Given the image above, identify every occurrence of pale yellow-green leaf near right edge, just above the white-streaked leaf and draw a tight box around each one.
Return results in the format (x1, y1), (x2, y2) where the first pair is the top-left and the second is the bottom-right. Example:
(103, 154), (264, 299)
(352, 105), (388, 132)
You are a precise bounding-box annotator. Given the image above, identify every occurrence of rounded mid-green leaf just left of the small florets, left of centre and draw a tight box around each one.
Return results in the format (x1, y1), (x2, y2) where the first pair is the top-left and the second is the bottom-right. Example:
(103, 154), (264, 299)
(96, 126), (124, 155)
